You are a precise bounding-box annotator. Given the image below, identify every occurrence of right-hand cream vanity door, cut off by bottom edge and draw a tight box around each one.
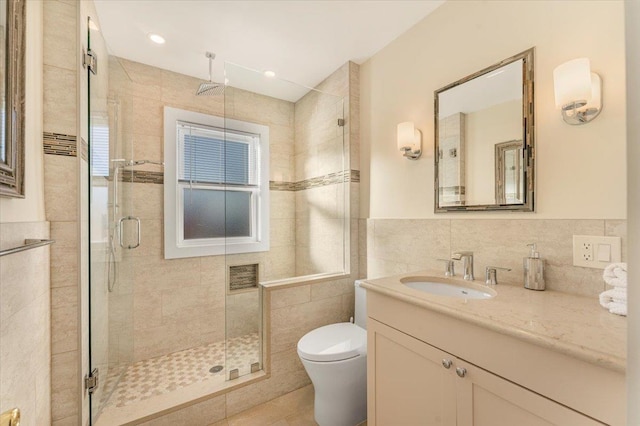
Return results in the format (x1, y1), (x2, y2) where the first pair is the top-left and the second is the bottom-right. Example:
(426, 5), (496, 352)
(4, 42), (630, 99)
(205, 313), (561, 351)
(455, 360), (603, 426)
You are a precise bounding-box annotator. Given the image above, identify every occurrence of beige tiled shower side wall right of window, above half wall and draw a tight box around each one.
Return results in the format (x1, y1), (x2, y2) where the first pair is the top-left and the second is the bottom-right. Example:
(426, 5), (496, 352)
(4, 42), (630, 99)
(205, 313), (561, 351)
(295, 62), (359, 276)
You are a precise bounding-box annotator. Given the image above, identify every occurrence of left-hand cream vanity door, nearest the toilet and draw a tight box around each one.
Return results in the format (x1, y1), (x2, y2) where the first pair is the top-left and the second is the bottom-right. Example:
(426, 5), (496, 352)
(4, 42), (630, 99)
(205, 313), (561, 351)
(367, 318), (456, 426)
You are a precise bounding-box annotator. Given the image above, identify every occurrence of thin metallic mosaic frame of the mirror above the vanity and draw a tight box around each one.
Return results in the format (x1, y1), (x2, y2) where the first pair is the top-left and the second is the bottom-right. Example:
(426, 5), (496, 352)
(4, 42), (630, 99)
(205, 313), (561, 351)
(433, 47), (535, 213)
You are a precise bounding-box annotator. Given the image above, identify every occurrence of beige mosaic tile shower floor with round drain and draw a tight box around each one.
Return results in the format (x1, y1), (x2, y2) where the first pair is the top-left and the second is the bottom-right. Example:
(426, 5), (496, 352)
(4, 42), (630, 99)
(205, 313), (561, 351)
(101, 333), (260, 408)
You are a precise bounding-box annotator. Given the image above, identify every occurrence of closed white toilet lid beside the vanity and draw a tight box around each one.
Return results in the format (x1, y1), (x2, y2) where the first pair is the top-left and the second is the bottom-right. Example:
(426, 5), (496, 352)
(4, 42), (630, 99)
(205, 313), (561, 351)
(298, 322), (367, 362)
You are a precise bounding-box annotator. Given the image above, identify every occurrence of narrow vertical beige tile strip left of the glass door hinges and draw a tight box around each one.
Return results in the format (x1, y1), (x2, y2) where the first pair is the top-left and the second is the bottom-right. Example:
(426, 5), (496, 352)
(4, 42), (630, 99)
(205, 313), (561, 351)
(43, 0), (80, 426)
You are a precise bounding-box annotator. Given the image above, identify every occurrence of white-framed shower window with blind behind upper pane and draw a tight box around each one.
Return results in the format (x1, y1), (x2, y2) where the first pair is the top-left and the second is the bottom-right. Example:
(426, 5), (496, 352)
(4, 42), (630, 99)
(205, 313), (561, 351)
(164, 107), (269, 259)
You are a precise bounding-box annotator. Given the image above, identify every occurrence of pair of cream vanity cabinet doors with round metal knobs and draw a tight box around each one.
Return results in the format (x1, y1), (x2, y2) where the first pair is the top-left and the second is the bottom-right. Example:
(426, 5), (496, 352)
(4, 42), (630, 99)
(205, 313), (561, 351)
(368, 320), (602, 426)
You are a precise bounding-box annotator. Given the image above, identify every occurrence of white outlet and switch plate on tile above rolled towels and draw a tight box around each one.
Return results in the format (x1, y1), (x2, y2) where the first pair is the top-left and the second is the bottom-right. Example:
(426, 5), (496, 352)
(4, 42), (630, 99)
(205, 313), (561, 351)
(573, 235), (622, 269)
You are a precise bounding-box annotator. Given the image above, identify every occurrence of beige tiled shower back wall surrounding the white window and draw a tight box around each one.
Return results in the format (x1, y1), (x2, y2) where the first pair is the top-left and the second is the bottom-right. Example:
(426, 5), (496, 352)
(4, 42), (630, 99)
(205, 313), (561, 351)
(110, 58), (295, 361)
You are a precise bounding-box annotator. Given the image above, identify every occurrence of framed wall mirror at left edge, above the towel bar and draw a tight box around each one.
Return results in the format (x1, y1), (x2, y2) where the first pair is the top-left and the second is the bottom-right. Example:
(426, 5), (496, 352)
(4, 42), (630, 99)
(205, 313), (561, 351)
(0, 0), (26, 198)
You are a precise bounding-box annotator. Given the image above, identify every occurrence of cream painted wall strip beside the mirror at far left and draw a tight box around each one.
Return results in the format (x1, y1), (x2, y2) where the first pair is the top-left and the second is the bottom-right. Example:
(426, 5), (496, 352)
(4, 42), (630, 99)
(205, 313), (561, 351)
(0, 2), (44, 223)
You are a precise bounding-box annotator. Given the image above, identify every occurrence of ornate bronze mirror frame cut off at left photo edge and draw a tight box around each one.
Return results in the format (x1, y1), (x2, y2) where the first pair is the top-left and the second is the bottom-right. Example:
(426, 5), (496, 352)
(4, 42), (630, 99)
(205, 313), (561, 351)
(0, 0), (26, 198)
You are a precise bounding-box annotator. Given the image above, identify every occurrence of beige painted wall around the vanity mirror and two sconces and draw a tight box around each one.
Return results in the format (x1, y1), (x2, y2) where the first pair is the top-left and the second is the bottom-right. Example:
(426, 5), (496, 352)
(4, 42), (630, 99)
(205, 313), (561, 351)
(361, 1), (626, 219)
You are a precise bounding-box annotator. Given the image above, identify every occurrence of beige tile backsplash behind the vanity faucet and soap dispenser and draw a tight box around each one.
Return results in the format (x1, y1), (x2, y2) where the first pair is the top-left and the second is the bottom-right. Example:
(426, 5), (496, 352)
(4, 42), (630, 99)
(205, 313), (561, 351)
(366, 219), (626, 296)
